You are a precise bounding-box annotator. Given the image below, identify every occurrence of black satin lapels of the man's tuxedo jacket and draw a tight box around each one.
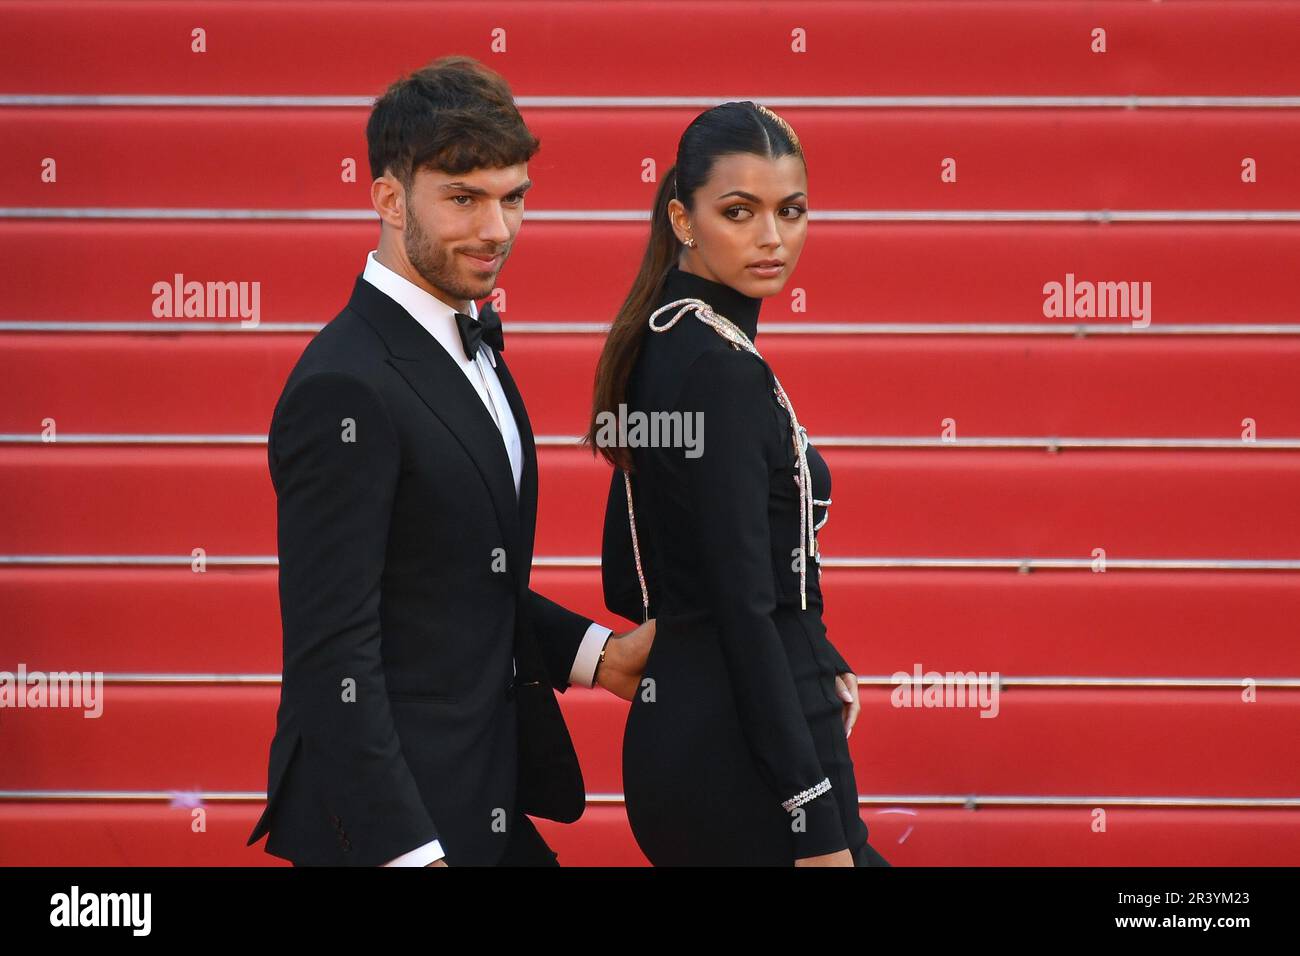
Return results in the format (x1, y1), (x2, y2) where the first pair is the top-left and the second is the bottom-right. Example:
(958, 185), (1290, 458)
(348, 276), (527, 585)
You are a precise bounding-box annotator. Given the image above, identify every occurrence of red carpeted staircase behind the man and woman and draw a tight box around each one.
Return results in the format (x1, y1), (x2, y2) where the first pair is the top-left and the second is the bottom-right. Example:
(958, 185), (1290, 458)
(0, 0), (1300, 865)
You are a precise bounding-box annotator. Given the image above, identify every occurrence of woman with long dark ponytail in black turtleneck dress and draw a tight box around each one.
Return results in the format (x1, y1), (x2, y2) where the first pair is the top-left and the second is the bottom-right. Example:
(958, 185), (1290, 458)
(586, 101), (889, 866)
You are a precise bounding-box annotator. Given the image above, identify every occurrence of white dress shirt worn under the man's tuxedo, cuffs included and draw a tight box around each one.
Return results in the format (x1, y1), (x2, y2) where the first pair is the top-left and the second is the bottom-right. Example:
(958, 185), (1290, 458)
(361, 250), (614, 866)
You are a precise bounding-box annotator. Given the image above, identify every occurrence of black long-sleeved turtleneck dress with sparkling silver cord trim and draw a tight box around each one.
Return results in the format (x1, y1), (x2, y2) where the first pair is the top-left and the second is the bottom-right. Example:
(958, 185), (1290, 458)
(601, 267), (889, 866)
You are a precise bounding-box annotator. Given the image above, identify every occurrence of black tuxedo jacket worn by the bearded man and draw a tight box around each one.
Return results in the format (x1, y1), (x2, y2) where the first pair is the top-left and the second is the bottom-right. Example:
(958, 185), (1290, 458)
(248, 276), (592, 866)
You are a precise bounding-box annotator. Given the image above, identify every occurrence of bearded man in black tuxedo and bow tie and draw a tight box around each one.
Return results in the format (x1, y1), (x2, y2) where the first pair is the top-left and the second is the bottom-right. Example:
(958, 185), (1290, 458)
(248, 57), (654, 866)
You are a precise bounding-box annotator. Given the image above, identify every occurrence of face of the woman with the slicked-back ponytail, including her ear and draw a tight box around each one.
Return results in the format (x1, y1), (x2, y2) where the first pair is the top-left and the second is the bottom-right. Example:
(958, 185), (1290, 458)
(668, 152), (809, 299)
